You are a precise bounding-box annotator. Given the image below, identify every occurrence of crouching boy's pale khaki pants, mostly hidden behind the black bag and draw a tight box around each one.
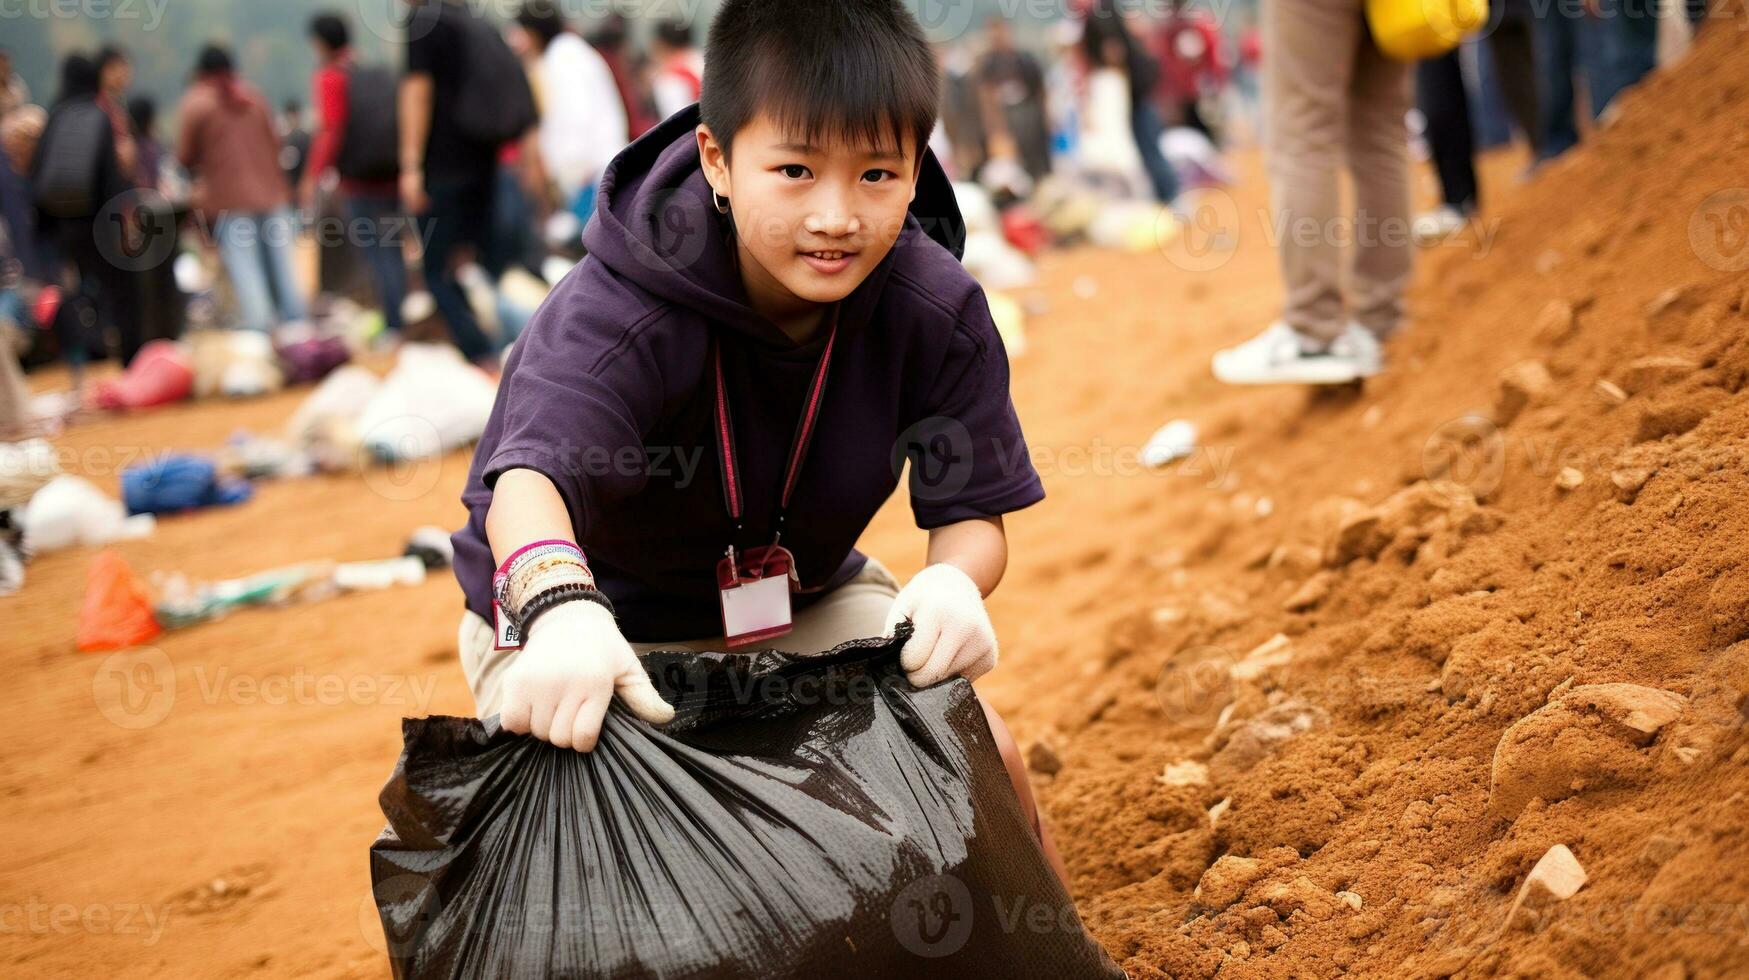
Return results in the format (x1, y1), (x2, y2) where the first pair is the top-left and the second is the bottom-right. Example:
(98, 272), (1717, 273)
(456, 558), (899, 718)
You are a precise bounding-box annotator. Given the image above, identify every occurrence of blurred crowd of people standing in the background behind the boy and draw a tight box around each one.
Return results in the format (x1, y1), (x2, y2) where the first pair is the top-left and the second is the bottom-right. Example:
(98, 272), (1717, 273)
(0, 0), (1704, 427)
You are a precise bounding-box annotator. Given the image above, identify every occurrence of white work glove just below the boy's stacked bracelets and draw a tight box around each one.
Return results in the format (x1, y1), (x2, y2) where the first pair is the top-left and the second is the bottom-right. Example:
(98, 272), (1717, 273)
(498, 599), (673, 753)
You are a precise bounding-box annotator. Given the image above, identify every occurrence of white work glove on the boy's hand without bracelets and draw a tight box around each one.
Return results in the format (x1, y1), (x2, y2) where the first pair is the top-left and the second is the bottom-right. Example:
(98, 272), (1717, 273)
(887, 565), (997, 688)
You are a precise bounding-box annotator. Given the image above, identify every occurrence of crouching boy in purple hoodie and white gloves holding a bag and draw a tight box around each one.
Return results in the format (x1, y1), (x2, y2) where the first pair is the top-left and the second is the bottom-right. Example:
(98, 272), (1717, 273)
(455, 0), (1062, 873)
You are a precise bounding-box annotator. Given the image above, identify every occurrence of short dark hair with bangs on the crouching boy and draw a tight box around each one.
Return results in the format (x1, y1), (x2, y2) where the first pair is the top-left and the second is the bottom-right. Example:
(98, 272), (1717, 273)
(700, 0), (941, 158)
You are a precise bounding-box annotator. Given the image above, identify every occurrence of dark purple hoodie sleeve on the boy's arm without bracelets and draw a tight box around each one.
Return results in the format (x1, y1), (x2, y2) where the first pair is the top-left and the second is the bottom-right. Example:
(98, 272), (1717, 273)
(902, 289), (1044, 529)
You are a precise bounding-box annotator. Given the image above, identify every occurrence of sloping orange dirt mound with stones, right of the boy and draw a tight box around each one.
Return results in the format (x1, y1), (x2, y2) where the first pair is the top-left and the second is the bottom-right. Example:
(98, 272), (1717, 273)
(1028, 11), (1749, 978)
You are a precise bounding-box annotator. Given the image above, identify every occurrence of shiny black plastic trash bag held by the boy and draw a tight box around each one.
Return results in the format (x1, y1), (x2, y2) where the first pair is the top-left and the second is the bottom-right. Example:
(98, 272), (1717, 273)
(371, 627), (1123, 980)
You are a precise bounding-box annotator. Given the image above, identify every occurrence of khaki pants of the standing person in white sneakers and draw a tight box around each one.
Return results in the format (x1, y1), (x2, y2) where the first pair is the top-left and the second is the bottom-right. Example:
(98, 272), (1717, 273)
(1263, 0), (1413, 341)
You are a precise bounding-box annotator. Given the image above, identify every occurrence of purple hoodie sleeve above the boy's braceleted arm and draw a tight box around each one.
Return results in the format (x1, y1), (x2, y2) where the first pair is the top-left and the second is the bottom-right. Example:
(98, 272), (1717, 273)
(474, 289), (663, 548)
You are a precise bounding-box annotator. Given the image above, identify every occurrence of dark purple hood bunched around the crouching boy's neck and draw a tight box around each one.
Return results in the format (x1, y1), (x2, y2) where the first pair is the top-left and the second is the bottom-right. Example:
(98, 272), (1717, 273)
(582, 103), (965, 347)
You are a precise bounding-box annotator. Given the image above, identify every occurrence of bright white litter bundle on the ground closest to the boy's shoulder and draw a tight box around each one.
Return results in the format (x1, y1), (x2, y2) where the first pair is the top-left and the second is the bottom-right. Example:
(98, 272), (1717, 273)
(359, 343), (498, 462)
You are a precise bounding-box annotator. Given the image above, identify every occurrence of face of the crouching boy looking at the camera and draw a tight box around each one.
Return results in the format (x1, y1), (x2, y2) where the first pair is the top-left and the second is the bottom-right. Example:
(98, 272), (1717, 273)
(698, 114), (918, 319)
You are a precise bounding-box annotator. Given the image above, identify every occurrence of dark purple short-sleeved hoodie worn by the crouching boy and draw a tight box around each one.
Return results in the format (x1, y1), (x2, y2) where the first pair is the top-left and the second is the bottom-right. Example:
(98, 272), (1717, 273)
(455, 107), (1044, 642)
